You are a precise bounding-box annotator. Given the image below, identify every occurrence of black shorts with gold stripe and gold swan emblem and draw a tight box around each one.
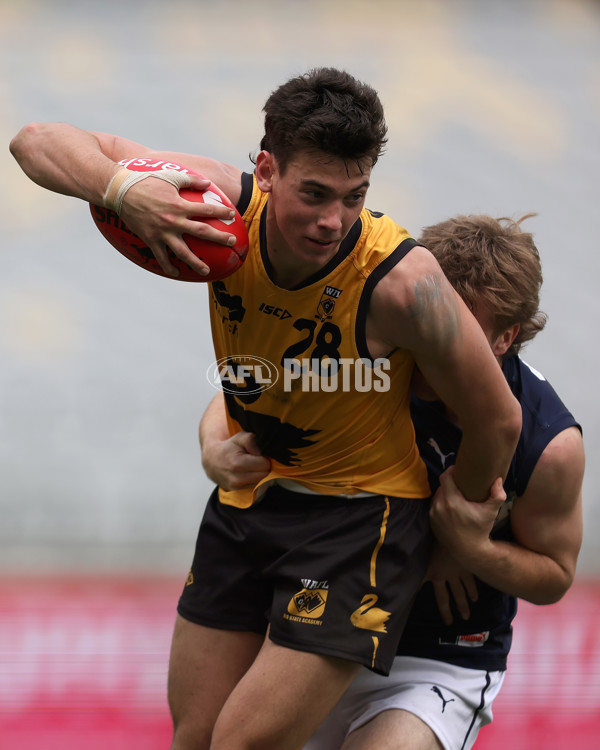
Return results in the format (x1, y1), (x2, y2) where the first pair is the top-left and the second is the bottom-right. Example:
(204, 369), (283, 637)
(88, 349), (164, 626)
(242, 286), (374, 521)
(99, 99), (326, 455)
(178, 486), (431, 675)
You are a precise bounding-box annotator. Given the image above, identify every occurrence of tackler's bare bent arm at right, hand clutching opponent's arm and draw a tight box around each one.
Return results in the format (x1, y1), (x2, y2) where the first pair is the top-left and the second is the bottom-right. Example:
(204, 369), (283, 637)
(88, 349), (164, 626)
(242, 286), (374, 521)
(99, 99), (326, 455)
(431, 427), (585, 604)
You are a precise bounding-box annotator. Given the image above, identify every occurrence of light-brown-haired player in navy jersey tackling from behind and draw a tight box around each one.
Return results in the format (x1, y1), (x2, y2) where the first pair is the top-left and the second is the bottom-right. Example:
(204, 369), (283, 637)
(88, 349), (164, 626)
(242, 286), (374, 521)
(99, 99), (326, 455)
(201, 216), (584, 750)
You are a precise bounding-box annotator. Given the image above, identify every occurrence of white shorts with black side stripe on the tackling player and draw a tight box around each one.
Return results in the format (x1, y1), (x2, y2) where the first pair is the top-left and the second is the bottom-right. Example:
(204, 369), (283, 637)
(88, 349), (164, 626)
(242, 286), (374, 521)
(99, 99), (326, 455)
(303, 656), (505, 750)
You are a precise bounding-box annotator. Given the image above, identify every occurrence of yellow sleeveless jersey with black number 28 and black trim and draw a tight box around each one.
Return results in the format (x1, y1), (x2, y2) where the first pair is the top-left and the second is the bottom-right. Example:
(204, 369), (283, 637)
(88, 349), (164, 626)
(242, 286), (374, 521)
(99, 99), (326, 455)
(210, 174), (430, 508)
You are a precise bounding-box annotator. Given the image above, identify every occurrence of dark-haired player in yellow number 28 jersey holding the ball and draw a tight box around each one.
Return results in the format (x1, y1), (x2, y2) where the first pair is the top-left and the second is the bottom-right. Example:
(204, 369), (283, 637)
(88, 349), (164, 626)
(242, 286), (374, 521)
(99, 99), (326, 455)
(11, 68), (521, 750)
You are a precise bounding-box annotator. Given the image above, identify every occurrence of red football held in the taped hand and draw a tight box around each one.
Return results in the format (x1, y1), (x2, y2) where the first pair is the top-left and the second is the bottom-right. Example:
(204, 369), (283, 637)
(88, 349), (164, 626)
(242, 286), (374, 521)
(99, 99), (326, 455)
(90, 158), (248, 281)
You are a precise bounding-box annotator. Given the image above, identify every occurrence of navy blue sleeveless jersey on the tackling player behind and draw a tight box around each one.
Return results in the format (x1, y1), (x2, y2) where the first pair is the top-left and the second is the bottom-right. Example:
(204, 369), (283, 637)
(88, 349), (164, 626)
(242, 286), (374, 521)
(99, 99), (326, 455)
(398, 356), (581, 671)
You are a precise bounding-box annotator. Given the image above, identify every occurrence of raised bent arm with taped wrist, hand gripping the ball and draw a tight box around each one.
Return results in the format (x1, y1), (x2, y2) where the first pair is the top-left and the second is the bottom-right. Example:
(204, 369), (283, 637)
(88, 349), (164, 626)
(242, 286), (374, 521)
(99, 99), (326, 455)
(10, 123), (241, 275)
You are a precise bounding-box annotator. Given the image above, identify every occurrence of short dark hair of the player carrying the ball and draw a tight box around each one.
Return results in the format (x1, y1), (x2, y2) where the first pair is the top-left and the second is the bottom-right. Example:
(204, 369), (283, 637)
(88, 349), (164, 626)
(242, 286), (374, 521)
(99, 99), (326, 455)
(260, 68), (387, 172)
